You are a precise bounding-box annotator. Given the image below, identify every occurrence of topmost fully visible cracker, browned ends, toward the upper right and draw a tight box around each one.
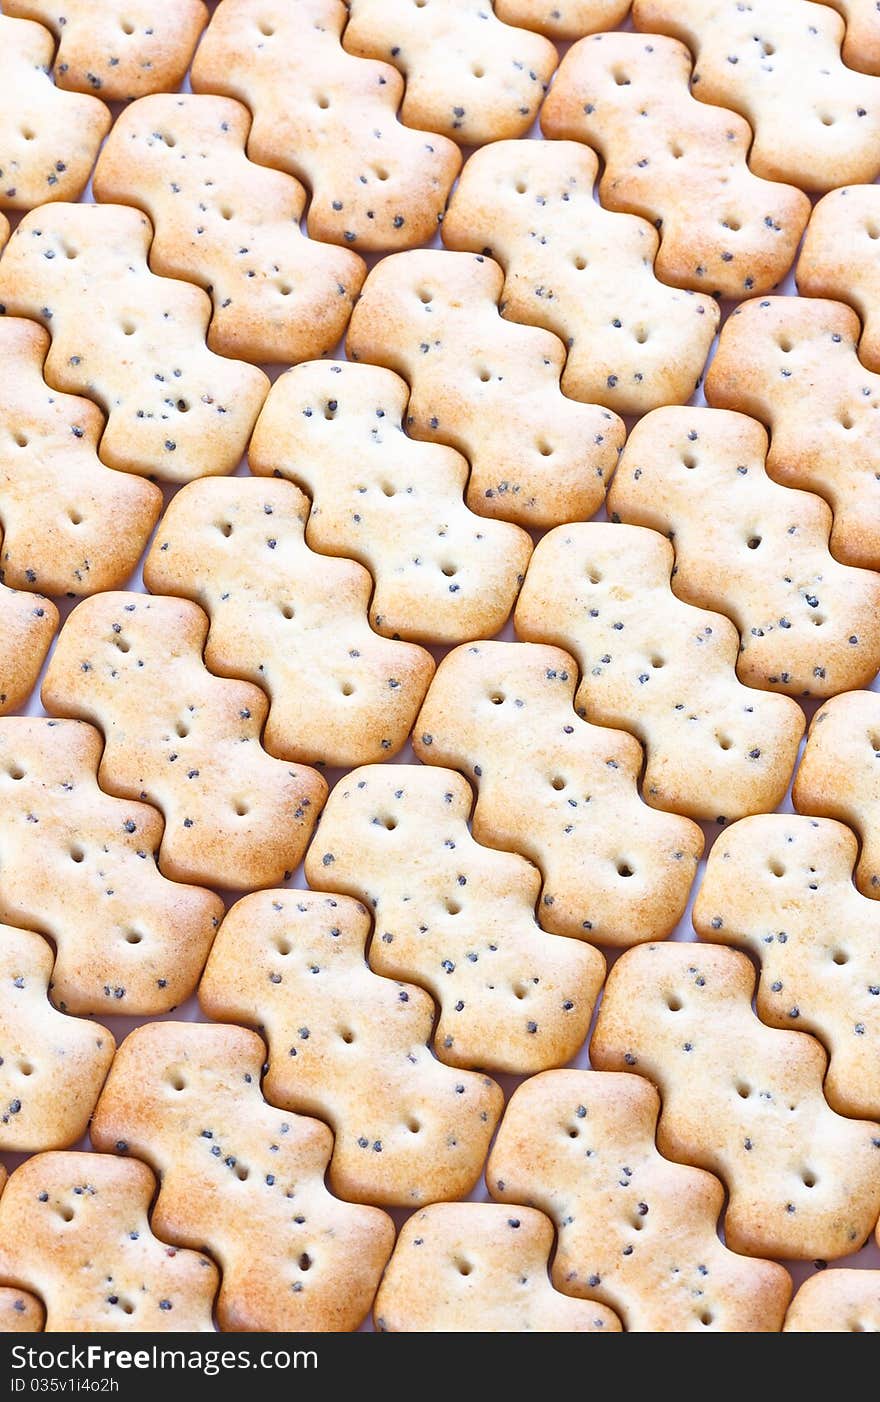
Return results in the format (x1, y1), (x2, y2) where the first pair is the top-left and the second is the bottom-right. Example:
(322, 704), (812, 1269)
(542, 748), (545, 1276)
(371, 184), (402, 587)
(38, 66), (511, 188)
(541, 34), (810, 299)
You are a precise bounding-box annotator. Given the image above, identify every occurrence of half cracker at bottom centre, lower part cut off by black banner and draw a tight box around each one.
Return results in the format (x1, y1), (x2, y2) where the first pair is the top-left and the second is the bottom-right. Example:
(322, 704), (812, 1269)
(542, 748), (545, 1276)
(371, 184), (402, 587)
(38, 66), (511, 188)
(373, 1203), (621, 1333)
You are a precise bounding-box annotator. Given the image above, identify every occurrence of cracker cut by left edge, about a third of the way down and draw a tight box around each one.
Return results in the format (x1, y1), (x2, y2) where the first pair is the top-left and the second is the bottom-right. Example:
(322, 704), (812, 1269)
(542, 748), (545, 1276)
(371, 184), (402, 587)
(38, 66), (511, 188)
(0, 317), (163, 594)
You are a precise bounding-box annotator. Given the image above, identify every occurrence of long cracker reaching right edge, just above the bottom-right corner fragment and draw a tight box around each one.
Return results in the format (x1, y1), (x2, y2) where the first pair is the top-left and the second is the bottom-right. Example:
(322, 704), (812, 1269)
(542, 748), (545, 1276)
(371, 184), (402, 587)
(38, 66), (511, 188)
(590, 944), (880, 1260)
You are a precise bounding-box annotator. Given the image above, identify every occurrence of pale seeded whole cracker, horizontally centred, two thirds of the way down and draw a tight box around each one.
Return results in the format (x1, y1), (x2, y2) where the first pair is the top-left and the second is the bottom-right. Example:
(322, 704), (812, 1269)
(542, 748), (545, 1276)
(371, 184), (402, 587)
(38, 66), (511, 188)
(305, 764), (605, 1074)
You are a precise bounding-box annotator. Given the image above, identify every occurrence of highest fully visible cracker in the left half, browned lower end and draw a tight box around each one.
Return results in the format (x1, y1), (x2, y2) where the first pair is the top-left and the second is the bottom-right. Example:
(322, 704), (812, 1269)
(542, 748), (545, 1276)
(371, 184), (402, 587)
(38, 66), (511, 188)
(94, 93), (367, 365)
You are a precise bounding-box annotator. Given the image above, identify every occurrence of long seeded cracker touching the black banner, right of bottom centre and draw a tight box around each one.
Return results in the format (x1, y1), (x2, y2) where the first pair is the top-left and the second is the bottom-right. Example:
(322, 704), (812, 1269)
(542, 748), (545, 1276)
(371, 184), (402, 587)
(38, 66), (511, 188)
(486, 1071), (792, 1333)
